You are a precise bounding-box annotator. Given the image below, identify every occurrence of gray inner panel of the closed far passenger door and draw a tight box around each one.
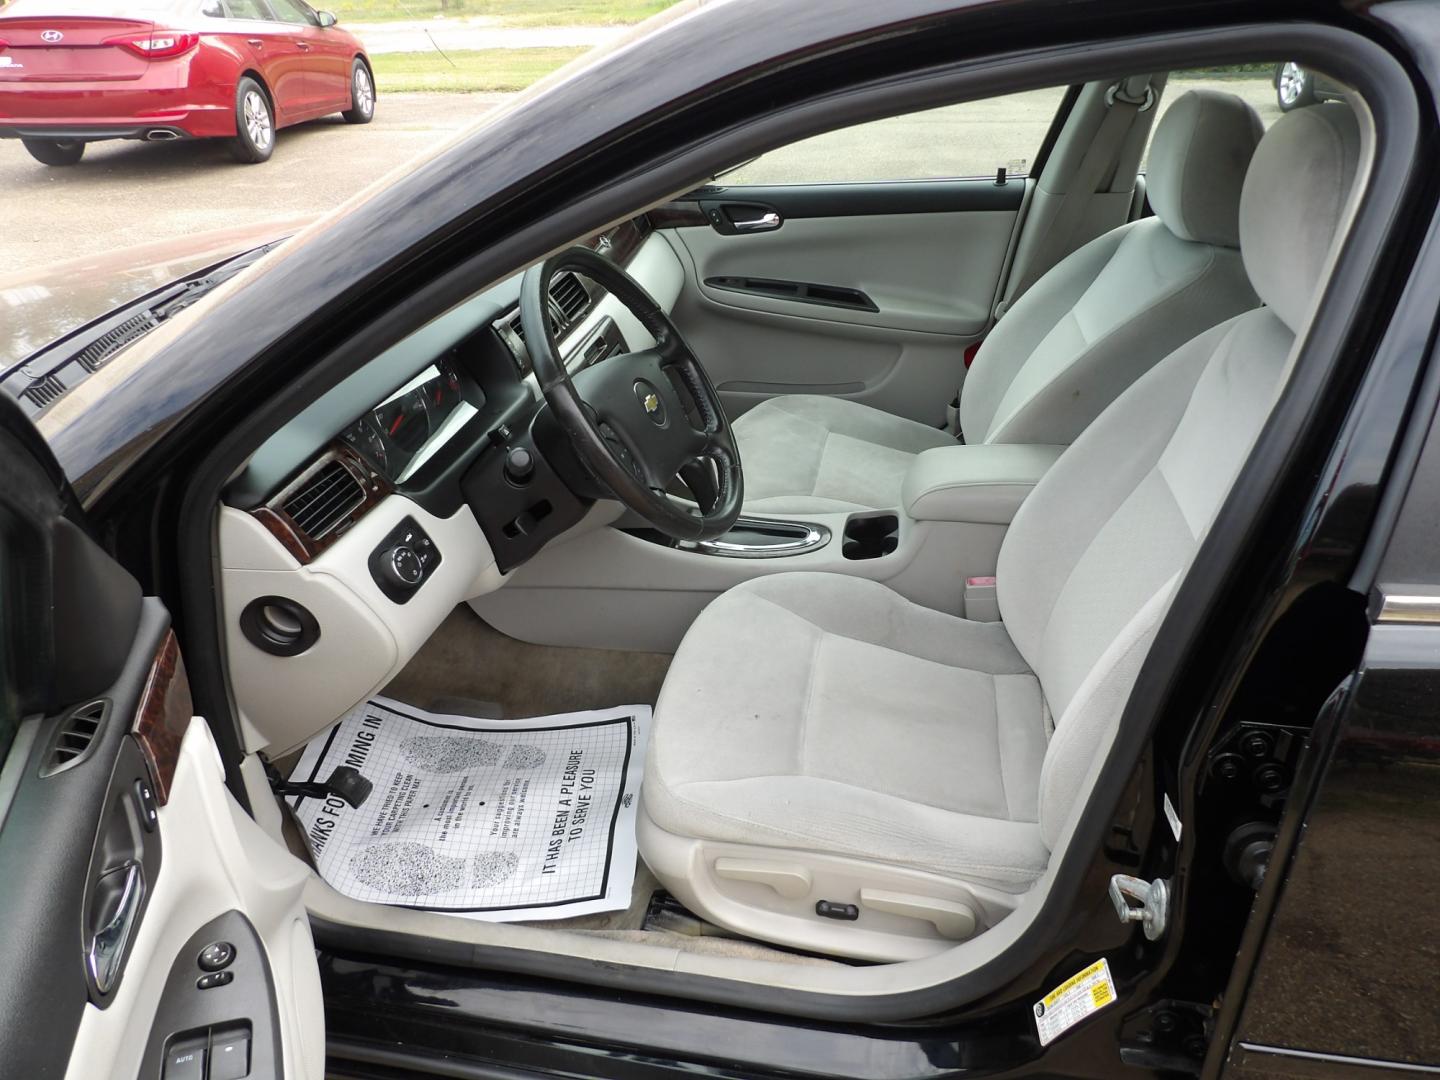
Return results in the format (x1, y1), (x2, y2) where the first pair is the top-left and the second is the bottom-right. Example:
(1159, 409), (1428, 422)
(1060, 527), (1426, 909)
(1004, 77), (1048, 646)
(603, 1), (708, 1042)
(660, 180), (1025, 423)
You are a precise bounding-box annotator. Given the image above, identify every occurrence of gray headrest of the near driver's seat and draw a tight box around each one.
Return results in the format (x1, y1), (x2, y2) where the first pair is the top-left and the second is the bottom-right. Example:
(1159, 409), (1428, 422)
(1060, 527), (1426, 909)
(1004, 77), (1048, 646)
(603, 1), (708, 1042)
(1240, 102), (1359, 333)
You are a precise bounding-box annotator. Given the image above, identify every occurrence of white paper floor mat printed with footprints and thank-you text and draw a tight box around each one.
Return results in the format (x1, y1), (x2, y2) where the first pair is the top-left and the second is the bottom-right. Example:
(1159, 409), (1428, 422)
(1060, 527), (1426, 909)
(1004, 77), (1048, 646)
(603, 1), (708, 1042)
(291, 697), (651, 922)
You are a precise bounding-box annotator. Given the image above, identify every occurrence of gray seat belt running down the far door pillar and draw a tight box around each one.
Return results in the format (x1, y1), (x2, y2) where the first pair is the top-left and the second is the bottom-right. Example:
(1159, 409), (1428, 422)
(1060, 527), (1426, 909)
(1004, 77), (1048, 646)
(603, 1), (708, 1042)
(995, 75), (1155, 321)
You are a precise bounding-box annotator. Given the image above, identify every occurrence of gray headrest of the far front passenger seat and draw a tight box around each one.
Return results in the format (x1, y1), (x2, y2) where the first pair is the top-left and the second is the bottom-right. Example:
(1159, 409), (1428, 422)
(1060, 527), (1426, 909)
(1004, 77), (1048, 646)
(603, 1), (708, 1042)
(1145, 91), (1264, 248)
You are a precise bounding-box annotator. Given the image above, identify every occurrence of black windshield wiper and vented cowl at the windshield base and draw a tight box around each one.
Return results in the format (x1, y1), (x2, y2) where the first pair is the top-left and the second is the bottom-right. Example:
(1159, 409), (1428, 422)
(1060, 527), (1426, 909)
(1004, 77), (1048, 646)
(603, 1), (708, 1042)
(0, 239), (284, 419)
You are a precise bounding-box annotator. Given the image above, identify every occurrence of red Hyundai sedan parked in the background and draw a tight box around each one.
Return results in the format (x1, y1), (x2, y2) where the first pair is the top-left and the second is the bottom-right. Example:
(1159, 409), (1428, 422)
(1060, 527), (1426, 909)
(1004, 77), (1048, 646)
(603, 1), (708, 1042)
(0, 0), (374, 166)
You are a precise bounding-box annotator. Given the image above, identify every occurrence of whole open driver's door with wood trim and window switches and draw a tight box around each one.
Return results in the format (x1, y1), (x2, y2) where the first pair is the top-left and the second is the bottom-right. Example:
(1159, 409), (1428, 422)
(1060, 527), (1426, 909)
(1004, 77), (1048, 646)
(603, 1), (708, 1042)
(0, 397), (324, 1080)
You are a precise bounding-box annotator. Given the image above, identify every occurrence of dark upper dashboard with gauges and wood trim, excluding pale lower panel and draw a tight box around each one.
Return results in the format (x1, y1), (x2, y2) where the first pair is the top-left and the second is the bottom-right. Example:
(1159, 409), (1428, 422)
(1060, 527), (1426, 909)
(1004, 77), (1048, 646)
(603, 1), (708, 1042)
(225, 217), (664, 585)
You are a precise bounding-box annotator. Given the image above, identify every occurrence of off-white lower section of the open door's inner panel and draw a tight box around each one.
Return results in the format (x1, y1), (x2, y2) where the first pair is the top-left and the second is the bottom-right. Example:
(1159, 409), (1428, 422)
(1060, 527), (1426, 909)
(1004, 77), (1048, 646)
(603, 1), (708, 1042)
(66, 720), (324, 1080)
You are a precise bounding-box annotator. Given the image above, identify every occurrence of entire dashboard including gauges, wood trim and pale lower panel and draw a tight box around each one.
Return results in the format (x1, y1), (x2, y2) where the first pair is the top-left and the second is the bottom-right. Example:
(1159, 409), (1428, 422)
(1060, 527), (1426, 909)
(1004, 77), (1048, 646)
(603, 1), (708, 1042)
(217, 222), (683, 753)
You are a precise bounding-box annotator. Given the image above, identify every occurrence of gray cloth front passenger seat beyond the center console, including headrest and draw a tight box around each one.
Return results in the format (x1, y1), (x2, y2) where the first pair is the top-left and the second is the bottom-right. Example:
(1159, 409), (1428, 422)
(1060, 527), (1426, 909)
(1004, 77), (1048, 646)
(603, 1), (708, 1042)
(734, 91), (1261, 514)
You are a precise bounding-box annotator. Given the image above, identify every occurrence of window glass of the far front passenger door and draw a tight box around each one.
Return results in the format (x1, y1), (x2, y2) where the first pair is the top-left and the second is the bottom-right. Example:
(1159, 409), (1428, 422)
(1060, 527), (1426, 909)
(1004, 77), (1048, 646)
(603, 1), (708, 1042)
(724, 86), (1066, 184)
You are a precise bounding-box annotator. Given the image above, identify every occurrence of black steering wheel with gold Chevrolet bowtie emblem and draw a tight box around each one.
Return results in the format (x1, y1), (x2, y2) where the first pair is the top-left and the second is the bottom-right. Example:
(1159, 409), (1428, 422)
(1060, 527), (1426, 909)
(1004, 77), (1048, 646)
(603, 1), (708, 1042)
(520, 246), (744, 540)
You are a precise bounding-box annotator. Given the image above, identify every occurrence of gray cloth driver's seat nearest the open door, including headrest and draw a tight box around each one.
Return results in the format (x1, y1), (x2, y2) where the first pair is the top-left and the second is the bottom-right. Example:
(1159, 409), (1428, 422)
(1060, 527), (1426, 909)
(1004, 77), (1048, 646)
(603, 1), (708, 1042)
(639, 105), (1359, 959)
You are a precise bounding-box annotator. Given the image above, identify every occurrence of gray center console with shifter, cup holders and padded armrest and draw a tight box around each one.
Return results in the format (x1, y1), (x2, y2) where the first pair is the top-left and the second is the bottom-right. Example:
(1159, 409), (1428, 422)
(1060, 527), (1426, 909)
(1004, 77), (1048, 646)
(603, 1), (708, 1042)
(471, 445), (1063, 652)
